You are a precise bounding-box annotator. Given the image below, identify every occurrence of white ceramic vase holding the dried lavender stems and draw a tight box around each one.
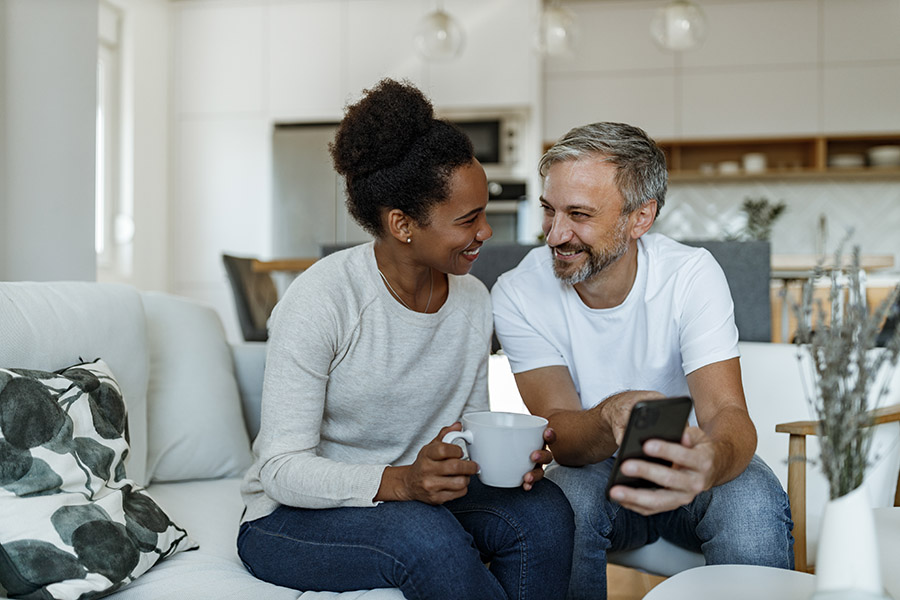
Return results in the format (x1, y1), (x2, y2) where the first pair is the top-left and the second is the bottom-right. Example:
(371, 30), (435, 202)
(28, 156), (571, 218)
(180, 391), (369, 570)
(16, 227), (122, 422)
(813, 486), (885, 600)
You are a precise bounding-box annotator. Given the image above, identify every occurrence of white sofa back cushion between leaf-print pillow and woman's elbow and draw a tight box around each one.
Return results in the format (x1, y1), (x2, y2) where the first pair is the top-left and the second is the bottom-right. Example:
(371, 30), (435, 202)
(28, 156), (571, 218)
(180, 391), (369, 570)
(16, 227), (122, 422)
(143, 292), (252, 481)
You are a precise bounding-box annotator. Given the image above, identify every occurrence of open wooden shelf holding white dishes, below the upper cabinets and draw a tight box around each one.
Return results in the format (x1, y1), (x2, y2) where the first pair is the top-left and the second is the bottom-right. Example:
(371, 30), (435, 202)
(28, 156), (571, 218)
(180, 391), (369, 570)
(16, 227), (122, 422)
(660, 133), (900, 181)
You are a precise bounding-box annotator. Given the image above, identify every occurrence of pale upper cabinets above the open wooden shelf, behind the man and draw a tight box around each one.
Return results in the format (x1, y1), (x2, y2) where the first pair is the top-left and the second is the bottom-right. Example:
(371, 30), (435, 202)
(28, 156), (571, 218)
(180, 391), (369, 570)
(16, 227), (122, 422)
(543, 0), (900, 141)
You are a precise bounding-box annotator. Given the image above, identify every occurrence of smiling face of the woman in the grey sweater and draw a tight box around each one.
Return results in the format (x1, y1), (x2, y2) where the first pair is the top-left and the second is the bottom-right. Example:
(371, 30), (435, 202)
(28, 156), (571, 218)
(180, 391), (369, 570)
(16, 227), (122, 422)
(413, 160), (493, 275)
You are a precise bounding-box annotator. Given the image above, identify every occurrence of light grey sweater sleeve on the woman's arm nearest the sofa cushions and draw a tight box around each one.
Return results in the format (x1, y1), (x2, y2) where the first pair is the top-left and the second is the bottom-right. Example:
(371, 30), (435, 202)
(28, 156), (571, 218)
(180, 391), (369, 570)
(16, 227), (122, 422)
(254, 274), (387, 508)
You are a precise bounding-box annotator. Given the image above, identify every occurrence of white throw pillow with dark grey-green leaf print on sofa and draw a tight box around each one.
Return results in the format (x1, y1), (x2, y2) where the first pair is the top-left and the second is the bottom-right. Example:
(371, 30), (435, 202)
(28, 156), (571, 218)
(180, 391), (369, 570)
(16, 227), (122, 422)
(0, 360), (196, 600)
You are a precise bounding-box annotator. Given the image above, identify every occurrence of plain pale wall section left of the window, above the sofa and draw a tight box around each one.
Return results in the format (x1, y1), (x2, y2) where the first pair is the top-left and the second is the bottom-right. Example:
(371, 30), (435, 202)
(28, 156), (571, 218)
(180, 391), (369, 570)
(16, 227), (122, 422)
(0, 0), (97, 280)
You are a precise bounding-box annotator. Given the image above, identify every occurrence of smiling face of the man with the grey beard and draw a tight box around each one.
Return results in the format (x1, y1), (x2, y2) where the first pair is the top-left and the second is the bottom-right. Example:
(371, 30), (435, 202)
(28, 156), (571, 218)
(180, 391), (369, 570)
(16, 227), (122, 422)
(541, 158), (632, 285)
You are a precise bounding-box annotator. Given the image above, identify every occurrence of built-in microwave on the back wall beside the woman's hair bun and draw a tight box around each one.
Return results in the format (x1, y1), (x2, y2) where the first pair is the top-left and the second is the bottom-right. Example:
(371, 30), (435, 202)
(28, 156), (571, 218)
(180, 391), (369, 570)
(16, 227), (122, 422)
(449, 115), (522, 173)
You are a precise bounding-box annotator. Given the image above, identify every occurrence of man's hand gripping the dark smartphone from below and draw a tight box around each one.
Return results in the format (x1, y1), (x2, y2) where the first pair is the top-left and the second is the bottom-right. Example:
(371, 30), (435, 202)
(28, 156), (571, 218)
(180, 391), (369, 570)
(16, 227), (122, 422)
(609, 427), (716, 515)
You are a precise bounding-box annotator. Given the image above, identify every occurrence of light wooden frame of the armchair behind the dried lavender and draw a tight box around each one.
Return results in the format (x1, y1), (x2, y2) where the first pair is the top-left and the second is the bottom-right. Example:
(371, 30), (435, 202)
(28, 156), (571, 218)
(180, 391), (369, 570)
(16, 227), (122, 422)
(775, 404), (900, 573)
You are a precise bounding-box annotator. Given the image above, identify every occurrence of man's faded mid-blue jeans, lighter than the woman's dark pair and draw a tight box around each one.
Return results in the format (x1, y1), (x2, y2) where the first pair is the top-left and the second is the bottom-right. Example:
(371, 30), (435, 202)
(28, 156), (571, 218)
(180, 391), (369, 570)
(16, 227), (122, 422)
(547, 456), (794, 600)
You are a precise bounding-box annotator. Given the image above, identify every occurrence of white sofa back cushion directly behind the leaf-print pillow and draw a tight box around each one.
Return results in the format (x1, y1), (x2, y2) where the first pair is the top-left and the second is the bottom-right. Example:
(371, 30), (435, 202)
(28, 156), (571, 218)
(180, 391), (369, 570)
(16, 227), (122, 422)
(0, 281), (149, 485)
